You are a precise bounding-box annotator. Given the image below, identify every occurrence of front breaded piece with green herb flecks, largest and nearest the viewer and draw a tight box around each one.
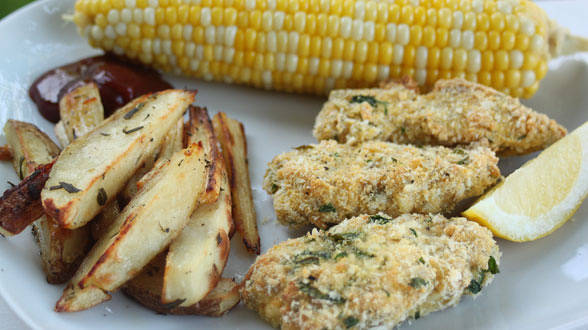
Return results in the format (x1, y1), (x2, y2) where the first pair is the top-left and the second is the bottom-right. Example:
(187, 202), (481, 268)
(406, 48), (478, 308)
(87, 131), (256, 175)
(241, 214), (500, 329)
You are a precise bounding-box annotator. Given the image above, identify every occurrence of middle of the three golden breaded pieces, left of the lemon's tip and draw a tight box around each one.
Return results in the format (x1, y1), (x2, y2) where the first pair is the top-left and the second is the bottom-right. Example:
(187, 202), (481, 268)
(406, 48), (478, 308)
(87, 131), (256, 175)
(263, 140), (500, 228)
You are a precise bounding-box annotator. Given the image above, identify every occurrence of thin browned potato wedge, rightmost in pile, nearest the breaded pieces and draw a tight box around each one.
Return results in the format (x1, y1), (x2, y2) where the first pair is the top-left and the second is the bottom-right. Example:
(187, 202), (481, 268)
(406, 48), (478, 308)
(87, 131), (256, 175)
(212, 112), (260, 254)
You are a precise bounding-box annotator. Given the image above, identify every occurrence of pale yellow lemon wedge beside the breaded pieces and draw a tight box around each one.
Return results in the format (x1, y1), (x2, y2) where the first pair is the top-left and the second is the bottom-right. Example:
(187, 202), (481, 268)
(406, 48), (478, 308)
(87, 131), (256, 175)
(463, 122), (588, 242)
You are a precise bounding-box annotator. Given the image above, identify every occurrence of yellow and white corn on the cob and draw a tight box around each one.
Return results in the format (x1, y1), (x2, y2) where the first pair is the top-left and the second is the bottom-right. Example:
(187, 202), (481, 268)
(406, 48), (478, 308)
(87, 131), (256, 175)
(73, 0), (588, 97)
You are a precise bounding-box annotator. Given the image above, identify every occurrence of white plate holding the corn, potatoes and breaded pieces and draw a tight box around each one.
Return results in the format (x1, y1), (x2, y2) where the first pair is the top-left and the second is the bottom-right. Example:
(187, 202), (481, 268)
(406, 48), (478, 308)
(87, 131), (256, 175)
(0, 0), (588, 329)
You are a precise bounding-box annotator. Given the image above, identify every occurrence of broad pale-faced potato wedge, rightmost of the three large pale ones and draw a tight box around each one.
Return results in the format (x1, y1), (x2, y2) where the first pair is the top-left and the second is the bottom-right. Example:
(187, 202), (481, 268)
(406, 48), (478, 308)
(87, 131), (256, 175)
(161, 151), (233, 307)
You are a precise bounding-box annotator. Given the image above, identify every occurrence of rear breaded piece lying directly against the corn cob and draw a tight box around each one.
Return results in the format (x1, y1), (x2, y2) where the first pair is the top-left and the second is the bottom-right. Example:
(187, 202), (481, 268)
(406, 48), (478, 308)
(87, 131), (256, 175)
(314, 79), (566, 155)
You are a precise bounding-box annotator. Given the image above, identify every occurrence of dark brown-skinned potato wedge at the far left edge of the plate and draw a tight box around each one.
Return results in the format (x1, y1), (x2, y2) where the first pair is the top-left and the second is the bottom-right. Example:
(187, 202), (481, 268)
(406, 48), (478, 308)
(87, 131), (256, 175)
(0, 163), (53, 236)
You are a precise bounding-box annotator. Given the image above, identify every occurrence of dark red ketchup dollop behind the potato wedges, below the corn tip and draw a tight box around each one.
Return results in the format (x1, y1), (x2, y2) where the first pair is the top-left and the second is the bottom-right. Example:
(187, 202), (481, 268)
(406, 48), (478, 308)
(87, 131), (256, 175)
(29, 54), (172, 123)
